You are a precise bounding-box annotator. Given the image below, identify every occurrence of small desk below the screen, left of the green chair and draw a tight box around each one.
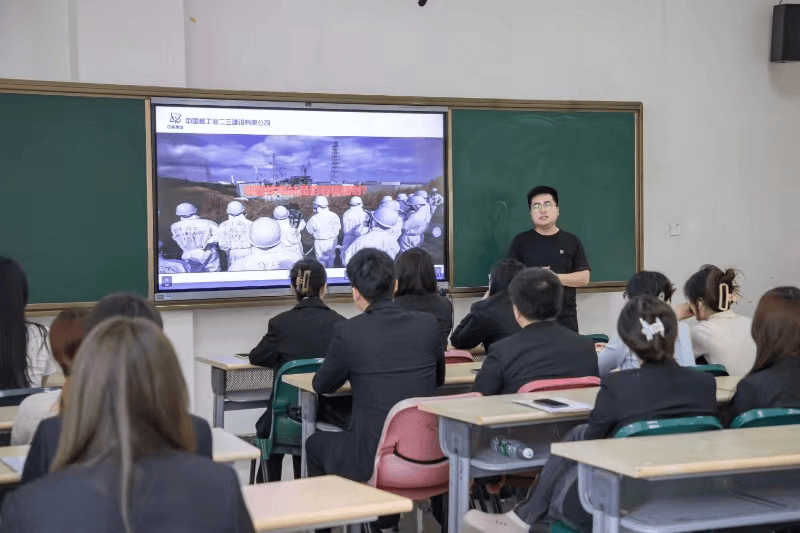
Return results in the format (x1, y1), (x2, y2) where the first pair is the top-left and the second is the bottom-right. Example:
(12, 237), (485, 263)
(195, 355), (273, 428)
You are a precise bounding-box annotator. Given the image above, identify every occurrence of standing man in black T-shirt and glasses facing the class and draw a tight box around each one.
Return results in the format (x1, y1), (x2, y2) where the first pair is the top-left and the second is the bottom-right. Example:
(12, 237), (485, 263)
(508, 186), (590, 332)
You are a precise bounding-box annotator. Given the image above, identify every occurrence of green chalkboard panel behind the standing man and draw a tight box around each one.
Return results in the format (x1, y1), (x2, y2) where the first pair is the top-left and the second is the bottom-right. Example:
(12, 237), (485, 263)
(452, 109), (637, 287)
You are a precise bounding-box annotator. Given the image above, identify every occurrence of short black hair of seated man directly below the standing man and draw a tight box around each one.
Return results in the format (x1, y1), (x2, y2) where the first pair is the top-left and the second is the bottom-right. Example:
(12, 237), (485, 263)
(508, 267), (564, 321)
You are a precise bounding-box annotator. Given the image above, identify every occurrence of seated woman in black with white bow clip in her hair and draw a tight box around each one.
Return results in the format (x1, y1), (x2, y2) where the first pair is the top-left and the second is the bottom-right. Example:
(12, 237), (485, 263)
(462, 295), (717, 533)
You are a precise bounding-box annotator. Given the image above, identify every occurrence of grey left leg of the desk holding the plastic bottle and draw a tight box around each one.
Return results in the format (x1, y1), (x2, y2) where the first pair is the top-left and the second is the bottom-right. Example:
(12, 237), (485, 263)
(439, 417), (472, 533)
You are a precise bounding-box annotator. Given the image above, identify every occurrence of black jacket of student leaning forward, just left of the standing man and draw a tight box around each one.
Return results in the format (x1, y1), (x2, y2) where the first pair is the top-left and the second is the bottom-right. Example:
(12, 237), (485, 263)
(450, 291), (522, 352)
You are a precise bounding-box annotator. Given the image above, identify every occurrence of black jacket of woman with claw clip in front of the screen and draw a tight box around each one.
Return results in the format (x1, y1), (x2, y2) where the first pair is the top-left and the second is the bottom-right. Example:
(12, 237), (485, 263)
(250, 298), (345, 370)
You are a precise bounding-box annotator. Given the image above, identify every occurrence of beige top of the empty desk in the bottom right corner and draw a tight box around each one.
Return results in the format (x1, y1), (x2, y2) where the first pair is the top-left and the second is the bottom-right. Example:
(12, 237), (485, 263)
(550, 426), (800, 478)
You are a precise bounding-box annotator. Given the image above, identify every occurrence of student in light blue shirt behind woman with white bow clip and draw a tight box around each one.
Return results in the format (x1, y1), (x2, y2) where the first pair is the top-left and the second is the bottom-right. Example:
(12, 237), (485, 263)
(597, 271), (694, 378)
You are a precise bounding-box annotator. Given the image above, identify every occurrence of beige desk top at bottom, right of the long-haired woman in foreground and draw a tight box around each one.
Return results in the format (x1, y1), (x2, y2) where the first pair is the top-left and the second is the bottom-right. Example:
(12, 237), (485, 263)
(242, 476), (412, 531)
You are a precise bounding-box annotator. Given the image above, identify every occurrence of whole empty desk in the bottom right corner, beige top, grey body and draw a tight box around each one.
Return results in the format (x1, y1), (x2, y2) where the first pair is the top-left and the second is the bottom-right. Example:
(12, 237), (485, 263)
(552, 426), (800, 533)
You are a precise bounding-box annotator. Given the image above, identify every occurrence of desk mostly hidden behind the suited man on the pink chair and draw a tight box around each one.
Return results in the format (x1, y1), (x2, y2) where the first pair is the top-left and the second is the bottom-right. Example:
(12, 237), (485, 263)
(282, 363), (482, 477)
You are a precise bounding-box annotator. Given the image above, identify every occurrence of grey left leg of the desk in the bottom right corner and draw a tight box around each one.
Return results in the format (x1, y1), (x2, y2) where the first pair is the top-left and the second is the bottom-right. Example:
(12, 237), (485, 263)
(578, 463), (621, 533)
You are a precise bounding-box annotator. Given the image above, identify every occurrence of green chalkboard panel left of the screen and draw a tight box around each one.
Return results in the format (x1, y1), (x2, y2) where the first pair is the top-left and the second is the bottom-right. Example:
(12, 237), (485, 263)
(0, 93), (148, 304)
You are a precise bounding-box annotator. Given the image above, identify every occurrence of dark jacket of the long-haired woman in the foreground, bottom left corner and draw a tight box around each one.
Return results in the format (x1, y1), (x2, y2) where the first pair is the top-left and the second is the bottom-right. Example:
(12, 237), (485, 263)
(0, 452), (253, 533)
